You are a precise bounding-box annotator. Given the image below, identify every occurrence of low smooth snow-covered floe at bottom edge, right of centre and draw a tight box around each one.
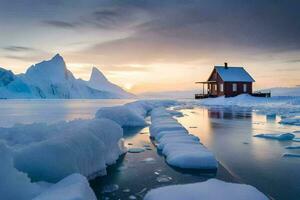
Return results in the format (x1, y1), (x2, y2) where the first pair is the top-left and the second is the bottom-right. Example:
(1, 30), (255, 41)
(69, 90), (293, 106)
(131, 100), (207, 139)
(144, 179), (268, 200)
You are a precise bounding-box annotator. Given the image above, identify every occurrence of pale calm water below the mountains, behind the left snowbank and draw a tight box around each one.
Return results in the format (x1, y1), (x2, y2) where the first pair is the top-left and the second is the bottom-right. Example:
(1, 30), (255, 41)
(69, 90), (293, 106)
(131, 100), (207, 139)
(0, 99), (134, 127)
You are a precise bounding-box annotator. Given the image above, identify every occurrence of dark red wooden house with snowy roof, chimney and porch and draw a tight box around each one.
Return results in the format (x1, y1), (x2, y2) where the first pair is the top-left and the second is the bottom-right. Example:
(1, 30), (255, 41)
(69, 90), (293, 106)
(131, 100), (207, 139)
(195, 63), (255, 99)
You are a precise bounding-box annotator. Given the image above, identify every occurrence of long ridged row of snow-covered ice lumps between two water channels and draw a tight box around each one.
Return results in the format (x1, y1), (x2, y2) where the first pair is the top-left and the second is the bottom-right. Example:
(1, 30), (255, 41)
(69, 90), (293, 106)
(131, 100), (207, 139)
(150, 107), (218, 169)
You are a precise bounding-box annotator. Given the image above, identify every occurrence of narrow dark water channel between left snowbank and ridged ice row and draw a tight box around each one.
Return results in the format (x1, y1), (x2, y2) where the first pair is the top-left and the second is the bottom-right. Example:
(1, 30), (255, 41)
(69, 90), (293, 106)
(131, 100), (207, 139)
(90, 122), (236, 199)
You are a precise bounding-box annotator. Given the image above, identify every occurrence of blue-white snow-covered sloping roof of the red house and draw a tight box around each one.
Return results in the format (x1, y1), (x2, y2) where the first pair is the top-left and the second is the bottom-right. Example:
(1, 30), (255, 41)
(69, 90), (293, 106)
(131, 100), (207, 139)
(215, 66), (255, 82)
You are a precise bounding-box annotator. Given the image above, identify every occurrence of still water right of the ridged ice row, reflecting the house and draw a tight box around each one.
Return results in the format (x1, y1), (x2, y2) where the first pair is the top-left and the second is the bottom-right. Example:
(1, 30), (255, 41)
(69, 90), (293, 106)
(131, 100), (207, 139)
(178, 107), (300, 200)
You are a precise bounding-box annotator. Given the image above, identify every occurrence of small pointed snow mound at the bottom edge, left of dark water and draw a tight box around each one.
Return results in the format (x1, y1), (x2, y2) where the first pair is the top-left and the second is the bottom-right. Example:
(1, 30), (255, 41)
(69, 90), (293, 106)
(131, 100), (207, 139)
(33, 174), (97, 200)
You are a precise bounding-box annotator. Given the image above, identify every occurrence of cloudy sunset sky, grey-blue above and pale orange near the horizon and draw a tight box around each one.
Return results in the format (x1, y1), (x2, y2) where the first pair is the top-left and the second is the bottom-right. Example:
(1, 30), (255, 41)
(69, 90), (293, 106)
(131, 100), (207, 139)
(0, 0), (300, 93)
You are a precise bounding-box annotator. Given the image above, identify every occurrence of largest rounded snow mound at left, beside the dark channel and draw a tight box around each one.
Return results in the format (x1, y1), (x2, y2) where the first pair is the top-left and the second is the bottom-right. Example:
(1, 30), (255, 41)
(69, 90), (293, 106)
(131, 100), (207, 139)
(1, 119), (124, 182)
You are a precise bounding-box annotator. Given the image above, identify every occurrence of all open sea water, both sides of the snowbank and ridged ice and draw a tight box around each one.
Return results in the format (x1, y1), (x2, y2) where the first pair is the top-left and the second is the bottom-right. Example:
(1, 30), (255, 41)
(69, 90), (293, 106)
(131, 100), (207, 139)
(0, 100), (300, 200)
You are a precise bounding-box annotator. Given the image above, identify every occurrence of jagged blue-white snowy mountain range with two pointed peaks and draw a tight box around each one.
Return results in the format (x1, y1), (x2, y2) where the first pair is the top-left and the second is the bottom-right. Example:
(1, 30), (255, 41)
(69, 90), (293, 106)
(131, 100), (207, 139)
(0, 54), (133, 99)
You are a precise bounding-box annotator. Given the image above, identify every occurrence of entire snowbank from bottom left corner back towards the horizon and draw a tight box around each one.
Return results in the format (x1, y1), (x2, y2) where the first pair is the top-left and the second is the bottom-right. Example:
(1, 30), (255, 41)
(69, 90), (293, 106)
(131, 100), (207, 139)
(0, 101), (175, 200)
